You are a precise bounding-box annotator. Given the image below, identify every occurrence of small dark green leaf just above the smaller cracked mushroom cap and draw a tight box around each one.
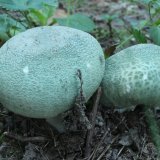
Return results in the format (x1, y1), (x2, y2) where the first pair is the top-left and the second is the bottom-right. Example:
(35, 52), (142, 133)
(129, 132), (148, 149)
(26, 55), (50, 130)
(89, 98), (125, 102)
(132, 29), (147, 43)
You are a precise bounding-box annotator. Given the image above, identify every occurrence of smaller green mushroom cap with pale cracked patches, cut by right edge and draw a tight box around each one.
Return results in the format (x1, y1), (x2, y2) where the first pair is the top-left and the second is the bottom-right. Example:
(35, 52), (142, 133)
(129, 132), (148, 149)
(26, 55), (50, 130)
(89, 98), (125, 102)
(102, 44), (160, 107)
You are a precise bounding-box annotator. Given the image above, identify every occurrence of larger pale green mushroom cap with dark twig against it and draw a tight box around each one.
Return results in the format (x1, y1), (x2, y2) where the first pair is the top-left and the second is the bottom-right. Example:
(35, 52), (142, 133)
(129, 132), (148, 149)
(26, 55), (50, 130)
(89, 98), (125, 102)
(0, 26), (105, 118)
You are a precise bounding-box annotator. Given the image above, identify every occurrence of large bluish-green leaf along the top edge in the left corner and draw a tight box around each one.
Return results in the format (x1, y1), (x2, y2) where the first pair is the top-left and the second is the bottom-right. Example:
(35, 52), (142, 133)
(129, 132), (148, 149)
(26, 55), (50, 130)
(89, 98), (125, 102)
(0, 0), (58, 11)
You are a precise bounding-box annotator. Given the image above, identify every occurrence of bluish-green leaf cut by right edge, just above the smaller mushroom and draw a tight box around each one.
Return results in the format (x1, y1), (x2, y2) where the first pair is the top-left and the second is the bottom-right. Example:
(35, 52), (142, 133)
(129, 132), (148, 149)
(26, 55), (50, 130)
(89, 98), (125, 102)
(149, 26), (160, 45)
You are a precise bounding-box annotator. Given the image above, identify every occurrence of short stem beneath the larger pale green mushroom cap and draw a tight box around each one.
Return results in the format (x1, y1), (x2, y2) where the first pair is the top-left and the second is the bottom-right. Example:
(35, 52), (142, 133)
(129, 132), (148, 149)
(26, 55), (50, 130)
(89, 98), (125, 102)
(46, 114), (65, 133)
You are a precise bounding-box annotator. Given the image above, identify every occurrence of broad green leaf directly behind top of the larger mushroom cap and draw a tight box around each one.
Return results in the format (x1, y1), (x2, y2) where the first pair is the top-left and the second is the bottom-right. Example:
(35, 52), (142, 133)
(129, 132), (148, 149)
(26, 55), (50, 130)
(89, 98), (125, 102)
(56, 13), (96, 32)
